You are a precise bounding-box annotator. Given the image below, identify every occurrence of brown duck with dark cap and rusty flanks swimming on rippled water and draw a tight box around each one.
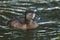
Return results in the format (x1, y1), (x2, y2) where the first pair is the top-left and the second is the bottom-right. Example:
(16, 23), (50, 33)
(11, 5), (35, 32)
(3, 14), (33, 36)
(8, 10), (38, 30)
